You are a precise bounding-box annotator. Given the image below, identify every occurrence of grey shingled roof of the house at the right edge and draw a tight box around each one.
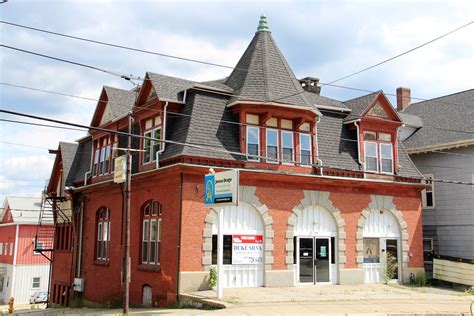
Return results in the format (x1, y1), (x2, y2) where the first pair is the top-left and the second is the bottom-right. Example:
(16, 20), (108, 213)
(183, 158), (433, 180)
(402, 89), (474, 149)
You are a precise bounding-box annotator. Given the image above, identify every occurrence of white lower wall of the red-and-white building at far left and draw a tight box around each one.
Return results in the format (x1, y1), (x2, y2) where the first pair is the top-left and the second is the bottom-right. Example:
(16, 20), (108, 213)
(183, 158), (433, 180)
(13, 264), (49, 304)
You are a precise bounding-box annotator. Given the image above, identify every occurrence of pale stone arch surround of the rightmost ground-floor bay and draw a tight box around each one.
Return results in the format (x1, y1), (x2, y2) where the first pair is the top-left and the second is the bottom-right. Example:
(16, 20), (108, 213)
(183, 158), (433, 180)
(356, 195), (408, 268)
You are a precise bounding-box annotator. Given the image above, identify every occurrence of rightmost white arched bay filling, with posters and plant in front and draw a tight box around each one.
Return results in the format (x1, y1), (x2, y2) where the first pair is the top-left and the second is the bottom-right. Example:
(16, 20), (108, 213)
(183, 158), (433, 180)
(362, 210), (401, 283)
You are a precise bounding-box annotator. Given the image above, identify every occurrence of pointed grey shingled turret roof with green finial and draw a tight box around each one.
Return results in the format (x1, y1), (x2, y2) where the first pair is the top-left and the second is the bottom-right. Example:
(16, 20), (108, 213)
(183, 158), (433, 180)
(226, 15), (313, 108)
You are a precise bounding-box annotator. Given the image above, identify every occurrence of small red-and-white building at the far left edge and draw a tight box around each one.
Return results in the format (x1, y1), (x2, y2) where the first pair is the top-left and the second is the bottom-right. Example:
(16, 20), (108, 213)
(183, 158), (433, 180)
(0, 196), (52, 304)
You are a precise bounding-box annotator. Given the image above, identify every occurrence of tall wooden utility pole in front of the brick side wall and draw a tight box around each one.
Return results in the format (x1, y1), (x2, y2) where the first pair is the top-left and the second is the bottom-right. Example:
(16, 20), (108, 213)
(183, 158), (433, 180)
(123, 112), (132, 315)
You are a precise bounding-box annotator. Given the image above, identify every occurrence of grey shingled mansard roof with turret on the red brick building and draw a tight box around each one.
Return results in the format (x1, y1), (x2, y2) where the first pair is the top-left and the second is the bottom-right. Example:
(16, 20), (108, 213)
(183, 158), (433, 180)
(60, 17), (420, 183)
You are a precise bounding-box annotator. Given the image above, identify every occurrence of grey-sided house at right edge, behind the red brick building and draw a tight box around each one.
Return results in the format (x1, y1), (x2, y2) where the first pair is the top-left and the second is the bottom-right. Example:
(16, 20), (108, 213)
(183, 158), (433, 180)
(398, 88), (474, 285)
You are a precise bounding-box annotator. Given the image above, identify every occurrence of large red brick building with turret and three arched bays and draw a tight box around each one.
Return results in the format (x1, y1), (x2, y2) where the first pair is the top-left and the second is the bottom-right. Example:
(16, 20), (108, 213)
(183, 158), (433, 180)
(49, 17), (426, 306)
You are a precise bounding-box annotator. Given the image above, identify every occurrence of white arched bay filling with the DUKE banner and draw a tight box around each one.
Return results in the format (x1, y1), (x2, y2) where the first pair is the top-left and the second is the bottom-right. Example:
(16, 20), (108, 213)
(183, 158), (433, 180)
(212, 202), (265, 288)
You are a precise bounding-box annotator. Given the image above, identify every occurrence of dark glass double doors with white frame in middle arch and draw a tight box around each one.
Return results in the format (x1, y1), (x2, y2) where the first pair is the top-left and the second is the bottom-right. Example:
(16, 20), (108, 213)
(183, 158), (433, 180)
(298, 237), (331, 284)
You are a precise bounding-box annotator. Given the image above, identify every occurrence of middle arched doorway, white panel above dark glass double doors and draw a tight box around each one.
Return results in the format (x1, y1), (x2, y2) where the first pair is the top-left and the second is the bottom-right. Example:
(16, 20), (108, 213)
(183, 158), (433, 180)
(294, 205), (337, 284)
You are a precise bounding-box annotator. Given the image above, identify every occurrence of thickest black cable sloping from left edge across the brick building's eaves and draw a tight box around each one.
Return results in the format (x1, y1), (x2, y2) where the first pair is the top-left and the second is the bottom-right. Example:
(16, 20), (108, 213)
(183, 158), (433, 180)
(0, 109), (473, 185)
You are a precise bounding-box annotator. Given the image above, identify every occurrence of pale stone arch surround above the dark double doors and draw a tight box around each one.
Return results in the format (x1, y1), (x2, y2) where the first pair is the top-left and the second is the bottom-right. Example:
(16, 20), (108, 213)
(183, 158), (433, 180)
(286, 190), (346, 270)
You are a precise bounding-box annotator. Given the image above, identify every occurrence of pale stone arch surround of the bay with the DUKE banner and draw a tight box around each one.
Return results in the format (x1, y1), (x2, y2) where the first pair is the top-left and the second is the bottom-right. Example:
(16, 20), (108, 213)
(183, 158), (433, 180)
(202, 186), (275, 271)
